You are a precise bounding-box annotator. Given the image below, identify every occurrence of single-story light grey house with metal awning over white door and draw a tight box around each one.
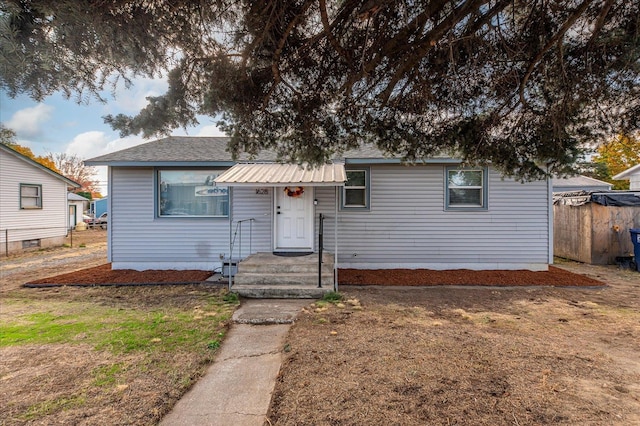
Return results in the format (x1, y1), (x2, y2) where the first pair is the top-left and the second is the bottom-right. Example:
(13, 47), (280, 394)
(85, 137), (553, 270)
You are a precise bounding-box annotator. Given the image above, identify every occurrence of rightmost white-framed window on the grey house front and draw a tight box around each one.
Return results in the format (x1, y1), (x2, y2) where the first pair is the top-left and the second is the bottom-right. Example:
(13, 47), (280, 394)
(446, 167), (487, 210)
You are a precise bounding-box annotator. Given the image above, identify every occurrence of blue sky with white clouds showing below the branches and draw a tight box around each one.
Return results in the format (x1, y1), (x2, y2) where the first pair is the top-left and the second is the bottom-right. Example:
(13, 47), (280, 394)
(0, 78), (223, 195)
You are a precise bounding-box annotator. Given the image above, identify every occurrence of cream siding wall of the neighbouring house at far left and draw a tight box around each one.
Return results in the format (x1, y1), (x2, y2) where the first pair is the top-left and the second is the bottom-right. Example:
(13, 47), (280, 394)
(0, 150), (69, 246)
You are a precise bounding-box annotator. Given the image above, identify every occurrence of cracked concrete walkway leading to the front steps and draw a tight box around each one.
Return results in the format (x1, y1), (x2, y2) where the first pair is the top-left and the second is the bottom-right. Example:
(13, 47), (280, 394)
(160, 299), (310, 426)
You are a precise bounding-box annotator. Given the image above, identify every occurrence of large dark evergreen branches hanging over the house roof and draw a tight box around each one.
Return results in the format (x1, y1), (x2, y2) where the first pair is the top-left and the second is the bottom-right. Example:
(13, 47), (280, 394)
(0, 0), (640, 178)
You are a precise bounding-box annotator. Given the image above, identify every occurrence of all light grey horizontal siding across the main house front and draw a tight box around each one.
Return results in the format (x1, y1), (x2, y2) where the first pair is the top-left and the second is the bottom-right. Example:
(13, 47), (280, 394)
(109, 164), (550, 269)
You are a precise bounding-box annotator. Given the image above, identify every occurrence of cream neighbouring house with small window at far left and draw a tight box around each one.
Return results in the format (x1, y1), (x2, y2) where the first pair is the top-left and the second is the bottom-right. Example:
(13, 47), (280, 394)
(0, 144), (80, 255)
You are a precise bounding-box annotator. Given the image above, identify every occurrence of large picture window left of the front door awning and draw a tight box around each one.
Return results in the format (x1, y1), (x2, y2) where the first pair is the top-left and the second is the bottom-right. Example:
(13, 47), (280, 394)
(157, 170), (229, 217)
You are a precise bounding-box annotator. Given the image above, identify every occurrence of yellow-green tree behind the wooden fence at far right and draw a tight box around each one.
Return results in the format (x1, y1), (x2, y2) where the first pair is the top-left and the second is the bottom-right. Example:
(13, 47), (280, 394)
(592, 135), (640, 189)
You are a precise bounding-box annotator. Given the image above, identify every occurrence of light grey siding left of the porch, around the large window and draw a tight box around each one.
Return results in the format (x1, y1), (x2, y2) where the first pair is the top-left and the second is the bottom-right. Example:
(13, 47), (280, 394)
(108, 167), (229, 270)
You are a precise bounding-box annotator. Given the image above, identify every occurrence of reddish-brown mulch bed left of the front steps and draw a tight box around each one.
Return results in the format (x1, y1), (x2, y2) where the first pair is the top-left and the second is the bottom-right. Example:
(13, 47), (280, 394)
(25, 263), (213, 286)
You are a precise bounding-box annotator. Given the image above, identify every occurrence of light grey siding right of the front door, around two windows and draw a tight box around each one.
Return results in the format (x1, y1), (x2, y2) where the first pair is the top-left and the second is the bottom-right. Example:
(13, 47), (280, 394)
(316, 165), (549, 269)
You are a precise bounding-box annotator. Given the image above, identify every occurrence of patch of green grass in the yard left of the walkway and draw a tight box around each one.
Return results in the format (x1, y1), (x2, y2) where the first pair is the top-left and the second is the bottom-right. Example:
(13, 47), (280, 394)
(0, 296), (235, 354)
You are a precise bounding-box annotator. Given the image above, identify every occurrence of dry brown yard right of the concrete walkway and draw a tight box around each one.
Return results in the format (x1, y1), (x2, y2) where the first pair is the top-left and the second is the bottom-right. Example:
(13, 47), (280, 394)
(268, 263), (640, 425)
